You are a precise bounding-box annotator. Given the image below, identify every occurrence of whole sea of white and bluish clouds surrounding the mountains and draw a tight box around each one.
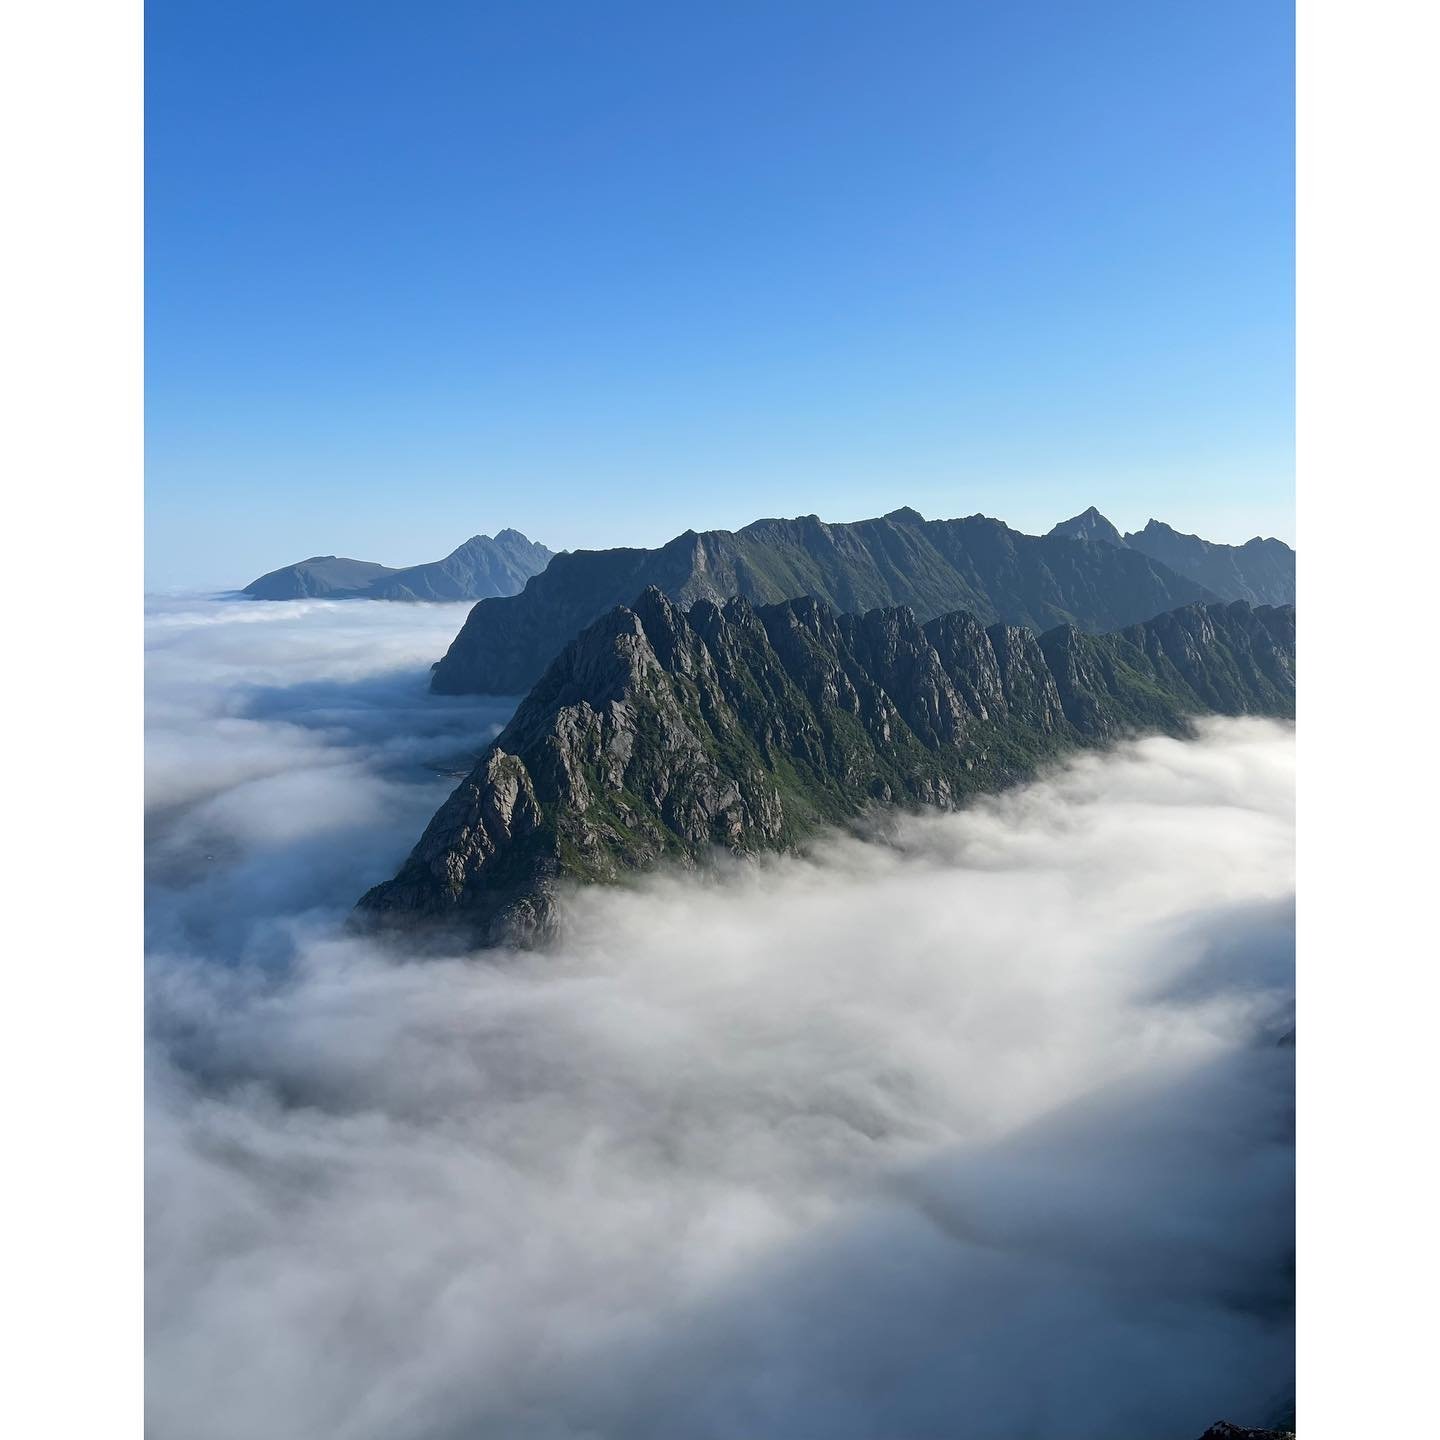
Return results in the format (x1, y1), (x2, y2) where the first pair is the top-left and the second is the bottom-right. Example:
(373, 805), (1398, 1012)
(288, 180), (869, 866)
(147, 599), (1295, 1440)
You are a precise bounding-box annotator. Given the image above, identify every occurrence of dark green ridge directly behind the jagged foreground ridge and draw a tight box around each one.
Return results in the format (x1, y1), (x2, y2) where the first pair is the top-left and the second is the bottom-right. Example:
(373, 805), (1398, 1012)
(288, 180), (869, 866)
(432, 510), (1215, 696)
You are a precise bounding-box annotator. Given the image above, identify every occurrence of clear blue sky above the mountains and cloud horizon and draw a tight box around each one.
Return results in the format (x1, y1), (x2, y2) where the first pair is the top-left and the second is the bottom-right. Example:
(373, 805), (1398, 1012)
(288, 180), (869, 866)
(147, 0), (1293, 586)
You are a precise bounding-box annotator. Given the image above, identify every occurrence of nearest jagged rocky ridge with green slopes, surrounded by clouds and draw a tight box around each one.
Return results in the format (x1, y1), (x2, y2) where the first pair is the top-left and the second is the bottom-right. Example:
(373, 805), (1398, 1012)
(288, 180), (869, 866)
(360, 587), (1295, 942)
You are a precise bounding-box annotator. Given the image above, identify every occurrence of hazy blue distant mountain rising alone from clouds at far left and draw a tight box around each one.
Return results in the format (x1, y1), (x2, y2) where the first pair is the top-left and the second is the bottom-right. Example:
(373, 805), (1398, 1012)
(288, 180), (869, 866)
(243, 530), (554, 600)
